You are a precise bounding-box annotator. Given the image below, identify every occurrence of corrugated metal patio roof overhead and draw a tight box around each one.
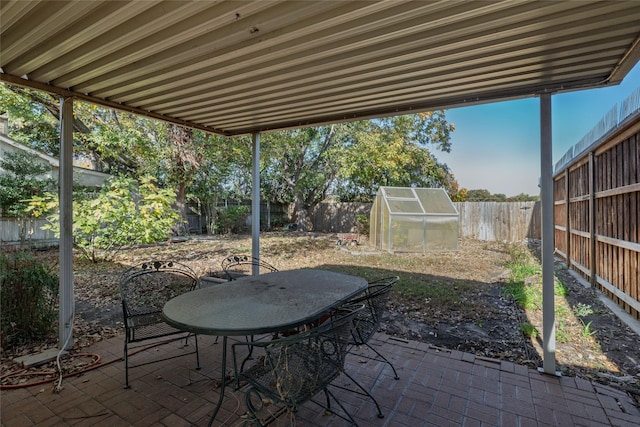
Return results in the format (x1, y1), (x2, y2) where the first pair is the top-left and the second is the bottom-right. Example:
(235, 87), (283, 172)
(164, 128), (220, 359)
(0, 0), (640, 135)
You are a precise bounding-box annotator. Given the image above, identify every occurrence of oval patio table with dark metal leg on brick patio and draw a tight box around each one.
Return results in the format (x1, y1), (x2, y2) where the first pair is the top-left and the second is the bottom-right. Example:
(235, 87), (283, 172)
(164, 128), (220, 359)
(162, 270), (367, 425)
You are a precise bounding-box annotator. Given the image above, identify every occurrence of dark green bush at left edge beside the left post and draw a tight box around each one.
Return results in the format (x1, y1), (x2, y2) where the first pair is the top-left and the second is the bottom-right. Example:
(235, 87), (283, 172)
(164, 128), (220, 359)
(0, 252), (59, 347)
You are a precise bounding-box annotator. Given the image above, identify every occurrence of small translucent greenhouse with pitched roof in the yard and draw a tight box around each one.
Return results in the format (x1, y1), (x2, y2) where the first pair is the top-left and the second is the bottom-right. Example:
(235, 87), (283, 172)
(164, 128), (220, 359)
(369, 187), (458, 253)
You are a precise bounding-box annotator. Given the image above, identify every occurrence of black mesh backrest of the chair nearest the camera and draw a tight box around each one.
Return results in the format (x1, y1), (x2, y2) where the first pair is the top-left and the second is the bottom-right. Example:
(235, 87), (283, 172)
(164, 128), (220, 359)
(241, 304), (363, 406)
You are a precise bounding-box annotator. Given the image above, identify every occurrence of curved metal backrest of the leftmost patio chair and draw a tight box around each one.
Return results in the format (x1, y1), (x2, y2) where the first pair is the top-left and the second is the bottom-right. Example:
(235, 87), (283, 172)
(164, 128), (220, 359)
(119, 261), (200, 318)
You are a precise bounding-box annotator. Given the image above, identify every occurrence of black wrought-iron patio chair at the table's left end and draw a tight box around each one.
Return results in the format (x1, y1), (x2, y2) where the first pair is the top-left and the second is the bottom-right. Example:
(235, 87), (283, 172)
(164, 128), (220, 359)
(119, 261), (200, 388)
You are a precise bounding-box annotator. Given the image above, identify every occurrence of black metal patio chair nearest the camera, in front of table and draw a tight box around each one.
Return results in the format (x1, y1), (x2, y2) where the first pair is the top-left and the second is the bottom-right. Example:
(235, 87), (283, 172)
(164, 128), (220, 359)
(232, 305), (363, 426)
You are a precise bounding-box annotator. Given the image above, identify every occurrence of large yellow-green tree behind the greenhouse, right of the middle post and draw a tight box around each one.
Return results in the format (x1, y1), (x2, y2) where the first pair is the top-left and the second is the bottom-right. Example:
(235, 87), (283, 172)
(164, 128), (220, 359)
(263, 111), (457, 230)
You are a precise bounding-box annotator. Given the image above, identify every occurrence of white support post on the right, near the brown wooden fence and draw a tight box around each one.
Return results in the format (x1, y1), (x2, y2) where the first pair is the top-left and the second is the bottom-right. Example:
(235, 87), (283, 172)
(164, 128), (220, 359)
(540, 93), (556, 375)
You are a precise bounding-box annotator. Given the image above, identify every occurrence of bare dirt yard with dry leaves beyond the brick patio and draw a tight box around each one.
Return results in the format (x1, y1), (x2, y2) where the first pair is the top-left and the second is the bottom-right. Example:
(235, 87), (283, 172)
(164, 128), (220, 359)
(2, 232), (640, 400)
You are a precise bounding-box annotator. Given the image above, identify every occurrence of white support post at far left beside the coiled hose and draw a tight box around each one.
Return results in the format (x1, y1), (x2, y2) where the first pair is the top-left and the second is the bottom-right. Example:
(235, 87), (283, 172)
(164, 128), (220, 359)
(58, 98), (74, 350)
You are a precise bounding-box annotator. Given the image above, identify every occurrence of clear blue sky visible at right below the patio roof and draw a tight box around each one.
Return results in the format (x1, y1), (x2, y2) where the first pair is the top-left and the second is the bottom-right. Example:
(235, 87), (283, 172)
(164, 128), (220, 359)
(434, 62), (640, 196)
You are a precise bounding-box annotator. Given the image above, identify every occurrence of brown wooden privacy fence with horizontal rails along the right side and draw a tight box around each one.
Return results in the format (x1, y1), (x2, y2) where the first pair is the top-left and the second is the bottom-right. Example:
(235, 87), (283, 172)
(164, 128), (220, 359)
(554, 109), (640, 319)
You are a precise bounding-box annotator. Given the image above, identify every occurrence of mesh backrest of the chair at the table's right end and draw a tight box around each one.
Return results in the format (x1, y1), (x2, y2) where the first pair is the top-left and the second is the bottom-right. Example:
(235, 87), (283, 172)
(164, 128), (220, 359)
(350, 276), (400, 345)
